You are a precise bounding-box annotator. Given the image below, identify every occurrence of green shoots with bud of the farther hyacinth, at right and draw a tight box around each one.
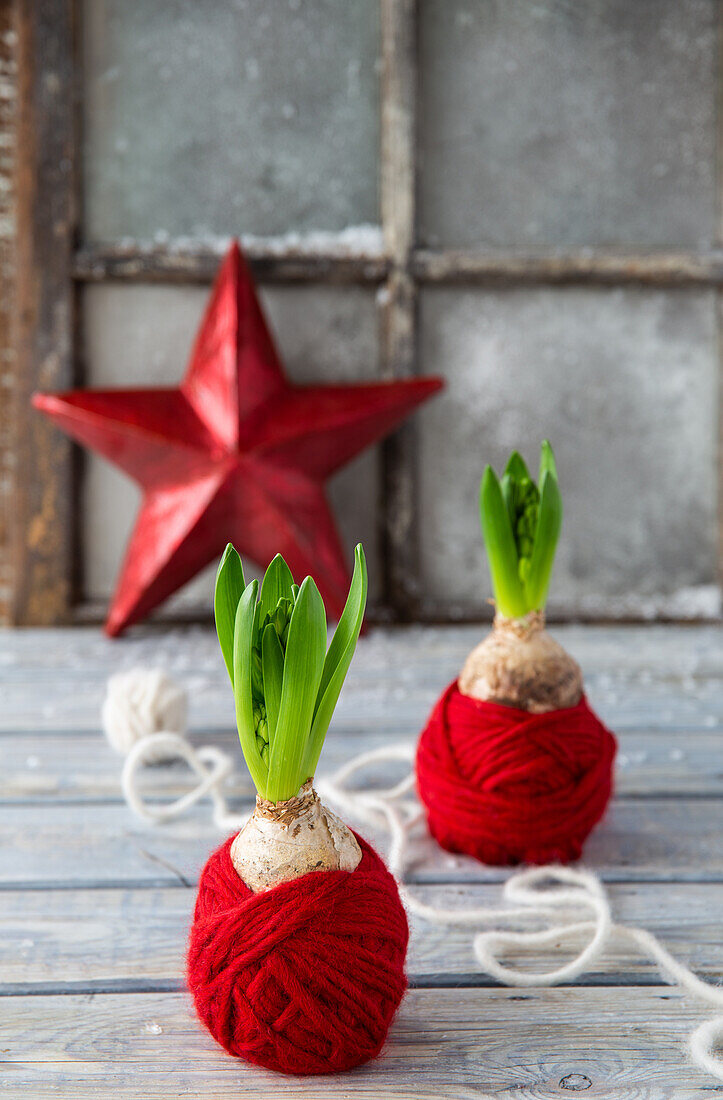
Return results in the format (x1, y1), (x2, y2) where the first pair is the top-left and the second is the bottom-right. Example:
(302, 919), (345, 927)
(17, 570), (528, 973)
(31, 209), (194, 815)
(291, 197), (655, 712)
(480, 440), (562, 618)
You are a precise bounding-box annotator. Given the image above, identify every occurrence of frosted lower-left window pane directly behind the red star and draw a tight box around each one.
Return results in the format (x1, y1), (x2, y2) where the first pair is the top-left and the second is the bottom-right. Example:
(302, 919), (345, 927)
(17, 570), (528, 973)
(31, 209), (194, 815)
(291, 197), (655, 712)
(81, 285), (381, 611)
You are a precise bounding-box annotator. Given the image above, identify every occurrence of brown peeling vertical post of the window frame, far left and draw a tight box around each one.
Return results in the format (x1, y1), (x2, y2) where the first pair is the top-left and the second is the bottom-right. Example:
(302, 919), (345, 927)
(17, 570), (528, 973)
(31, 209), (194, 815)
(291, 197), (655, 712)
(12, 0), (75, 624)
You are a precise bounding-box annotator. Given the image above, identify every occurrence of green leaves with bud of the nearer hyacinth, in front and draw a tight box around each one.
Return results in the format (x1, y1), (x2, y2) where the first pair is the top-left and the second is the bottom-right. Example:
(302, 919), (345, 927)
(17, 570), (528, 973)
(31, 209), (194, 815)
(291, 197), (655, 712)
(213, 543), (366, 802)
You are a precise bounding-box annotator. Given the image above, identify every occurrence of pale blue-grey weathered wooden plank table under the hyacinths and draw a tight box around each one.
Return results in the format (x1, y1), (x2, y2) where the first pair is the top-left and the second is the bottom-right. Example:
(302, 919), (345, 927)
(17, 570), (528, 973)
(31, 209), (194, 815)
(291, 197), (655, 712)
(0, 626), (723, 1100)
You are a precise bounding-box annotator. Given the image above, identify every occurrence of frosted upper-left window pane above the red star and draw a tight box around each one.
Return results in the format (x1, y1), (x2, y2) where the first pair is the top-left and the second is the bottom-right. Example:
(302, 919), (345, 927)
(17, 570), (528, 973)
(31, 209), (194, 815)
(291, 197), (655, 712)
(83, 0), (379, 241)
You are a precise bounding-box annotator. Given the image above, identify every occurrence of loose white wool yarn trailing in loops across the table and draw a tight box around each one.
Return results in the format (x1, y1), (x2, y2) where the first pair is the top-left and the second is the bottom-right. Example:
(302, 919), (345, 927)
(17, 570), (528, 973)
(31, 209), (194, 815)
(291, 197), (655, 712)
(103, 669), (723, 1080)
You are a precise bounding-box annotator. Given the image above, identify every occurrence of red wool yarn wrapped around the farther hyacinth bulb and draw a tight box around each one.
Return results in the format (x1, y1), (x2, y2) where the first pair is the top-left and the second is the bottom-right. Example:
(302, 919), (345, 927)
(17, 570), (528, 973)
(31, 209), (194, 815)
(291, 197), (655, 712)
(417, 681), (617, 865)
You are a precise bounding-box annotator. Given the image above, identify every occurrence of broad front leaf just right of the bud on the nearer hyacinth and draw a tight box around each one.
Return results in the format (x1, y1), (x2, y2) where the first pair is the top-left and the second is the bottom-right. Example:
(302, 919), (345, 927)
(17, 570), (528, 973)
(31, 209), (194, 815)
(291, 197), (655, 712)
(266, 576), (327, 802)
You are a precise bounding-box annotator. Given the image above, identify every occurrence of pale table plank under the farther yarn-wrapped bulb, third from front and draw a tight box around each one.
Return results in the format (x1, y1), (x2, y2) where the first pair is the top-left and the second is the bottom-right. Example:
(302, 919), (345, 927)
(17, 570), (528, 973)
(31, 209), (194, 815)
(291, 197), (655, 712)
(0, 798), (723, 889)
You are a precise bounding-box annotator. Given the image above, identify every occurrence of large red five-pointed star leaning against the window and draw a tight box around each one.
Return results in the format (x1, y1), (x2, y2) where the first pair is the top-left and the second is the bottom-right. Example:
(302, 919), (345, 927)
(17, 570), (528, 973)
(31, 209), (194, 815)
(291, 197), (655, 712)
(33, 242), (442, 635)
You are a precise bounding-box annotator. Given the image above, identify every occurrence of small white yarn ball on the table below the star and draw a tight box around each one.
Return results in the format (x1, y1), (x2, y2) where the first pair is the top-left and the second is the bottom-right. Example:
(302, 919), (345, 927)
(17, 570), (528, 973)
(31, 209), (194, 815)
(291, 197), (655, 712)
(102, 669), (187, 762)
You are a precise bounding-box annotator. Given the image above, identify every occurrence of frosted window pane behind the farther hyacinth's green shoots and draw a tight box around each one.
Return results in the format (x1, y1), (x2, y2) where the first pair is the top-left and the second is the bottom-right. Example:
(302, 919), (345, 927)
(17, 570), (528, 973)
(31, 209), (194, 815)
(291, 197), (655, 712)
(418, 289), (717, 614)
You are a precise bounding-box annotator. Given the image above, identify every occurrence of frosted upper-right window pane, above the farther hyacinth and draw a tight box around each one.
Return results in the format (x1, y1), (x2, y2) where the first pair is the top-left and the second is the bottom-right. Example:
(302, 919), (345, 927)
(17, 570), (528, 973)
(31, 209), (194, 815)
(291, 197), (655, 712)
(419, 0), (716, 248)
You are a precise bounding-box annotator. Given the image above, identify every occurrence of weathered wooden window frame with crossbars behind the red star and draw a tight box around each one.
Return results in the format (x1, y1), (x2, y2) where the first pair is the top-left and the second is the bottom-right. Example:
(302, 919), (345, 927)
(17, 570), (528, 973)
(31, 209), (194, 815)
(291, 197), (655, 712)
(7, 0), (723, 625)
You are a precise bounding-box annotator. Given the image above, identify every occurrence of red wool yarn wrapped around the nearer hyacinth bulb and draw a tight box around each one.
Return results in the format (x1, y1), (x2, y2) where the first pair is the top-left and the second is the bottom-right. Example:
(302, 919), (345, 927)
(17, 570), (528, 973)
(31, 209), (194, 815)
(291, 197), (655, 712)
(188, 837), (409, 1074)
